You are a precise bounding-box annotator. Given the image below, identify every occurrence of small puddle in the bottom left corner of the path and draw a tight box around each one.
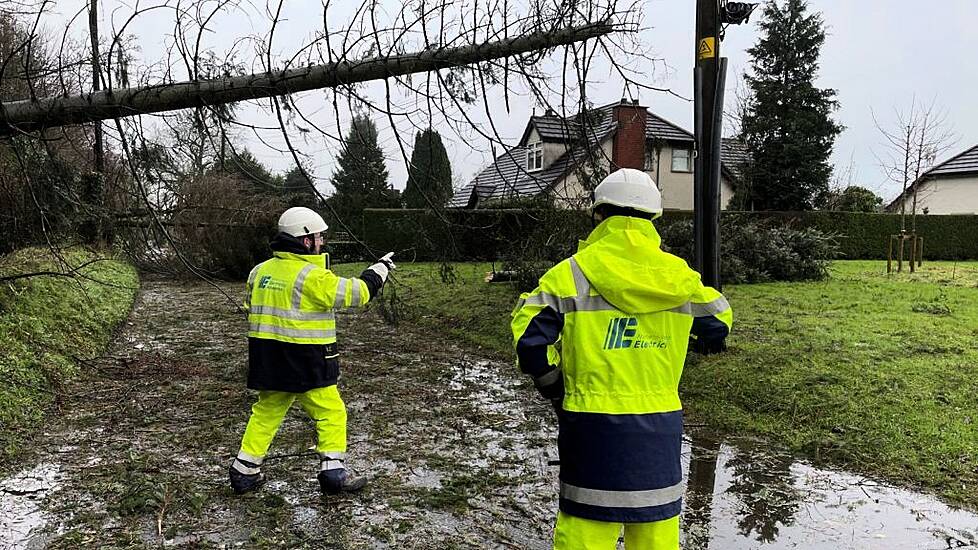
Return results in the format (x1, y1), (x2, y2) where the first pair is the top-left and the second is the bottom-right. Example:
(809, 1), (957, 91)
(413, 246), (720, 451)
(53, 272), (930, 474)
(0, 463), (62, 550)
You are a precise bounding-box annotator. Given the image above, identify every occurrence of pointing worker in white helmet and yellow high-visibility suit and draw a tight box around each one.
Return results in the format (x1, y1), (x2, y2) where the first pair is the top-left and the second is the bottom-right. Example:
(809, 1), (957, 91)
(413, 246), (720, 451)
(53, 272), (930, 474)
(228, 206), (395, 495)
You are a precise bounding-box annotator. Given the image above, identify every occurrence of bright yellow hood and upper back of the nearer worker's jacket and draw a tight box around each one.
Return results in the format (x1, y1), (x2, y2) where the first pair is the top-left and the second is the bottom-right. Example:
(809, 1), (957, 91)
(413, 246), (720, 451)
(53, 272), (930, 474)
(562, 217), (702, 414)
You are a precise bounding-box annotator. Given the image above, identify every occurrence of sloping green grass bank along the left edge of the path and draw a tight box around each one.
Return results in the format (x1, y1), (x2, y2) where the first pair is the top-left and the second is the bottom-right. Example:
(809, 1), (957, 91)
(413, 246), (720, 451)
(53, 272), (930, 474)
(0, 248), (139, 458)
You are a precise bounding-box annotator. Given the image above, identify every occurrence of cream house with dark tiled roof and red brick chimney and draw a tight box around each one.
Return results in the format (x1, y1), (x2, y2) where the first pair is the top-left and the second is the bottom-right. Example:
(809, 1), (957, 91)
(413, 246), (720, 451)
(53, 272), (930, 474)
(449, 100), (749, 210)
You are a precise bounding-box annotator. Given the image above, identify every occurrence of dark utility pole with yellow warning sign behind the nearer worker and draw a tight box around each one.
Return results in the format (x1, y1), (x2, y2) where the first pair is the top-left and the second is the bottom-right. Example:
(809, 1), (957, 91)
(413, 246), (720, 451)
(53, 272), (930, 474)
(693, 0), (757, 290)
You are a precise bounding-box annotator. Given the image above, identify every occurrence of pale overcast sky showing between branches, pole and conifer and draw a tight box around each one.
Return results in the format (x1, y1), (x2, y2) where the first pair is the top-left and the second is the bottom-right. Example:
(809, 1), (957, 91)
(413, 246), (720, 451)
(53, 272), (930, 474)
(47, 0), (978, 199)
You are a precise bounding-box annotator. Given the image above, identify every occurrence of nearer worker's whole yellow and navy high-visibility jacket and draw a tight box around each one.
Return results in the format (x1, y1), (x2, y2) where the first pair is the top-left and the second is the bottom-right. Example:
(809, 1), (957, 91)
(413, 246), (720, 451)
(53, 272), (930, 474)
(512, 216), (733, 522)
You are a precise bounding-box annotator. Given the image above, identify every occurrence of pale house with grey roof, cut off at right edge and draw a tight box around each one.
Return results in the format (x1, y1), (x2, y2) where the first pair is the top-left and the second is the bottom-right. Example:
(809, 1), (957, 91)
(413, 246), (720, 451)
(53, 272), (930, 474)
(886, 145), (978, 214)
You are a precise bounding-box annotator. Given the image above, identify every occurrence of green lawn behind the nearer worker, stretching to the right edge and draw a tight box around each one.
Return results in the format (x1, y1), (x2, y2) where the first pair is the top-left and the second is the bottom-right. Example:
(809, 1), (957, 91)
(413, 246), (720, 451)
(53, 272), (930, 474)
(338, 261), (978, 506)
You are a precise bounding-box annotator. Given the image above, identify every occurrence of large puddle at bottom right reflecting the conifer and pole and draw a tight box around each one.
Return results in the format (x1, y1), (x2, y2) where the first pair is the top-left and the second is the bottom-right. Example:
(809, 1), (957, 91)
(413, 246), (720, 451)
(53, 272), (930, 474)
(683, 434), (978, 550)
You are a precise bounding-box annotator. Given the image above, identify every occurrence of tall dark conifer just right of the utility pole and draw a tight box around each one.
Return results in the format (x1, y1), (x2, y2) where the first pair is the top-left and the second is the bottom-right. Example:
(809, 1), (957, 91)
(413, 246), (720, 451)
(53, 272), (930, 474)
(734, 0), (843, 210)
